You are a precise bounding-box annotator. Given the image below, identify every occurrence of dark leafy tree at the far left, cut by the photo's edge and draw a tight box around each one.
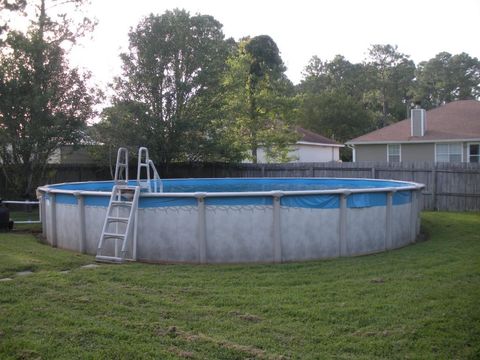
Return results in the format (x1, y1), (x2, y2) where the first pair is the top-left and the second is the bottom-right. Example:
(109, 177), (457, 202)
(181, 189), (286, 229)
(0, 0), (97, 196)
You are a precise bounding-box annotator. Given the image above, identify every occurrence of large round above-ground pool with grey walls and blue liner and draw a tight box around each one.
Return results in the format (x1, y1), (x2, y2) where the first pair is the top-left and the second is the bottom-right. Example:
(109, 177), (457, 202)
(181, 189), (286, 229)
(38, 178), (423, 263)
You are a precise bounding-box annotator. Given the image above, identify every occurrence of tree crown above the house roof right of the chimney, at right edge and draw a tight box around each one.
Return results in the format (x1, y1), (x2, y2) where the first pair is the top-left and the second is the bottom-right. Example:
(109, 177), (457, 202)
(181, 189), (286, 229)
(414, 52), (480, 109)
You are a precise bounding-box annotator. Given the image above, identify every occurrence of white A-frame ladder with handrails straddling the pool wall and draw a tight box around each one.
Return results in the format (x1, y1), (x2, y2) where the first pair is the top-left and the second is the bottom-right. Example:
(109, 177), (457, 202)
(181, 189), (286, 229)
(95, 147), (163, 263)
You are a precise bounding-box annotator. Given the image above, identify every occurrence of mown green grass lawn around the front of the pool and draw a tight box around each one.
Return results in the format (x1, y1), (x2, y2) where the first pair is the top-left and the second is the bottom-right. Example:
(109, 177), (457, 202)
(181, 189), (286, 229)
(0, 213), (480, 359)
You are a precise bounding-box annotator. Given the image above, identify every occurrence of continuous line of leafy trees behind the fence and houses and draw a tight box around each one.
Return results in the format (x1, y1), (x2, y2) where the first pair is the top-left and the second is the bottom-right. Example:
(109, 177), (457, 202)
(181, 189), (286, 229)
(0, 0), (480, 195)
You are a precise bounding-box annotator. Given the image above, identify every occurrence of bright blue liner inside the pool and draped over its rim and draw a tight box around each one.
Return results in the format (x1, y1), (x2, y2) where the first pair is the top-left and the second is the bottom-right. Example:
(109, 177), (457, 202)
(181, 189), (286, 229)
(47, 178), (412, 209)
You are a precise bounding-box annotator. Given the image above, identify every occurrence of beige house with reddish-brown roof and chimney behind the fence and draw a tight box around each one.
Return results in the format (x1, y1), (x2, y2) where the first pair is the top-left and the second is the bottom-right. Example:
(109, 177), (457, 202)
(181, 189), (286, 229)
(346, 100), (480, 163)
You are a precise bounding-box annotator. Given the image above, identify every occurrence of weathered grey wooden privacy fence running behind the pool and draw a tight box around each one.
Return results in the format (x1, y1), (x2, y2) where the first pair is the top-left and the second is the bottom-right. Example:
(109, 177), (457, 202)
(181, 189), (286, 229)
(4, 162), (480, 211)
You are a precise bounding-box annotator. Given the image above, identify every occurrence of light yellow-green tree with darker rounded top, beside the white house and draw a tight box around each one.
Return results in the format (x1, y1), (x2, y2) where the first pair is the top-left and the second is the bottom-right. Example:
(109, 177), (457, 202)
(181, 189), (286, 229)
(223, 35), (297, 163)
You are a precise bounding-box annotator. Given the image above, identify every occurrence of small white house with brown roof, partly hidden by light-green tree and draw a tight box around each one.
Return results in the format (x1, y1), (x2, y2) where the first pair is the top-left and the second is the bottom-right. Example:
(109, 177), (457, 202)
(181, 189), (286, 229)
(257, 127), (345, 163)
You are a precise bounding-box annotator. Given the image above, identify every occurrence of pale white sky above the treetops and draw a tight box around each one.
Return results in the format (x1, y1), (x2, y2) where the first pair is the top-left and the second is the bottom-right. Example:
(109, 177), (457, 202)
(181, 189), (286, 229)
(66, 0), (480, 87)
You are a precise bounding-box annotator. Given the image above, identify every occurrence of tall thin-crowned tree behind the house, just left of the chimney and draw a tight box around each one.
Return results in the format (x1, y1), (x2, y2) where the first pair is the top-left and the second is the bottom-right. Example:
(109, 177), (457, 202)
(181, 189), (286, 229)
(366, 45), (415, 128)
